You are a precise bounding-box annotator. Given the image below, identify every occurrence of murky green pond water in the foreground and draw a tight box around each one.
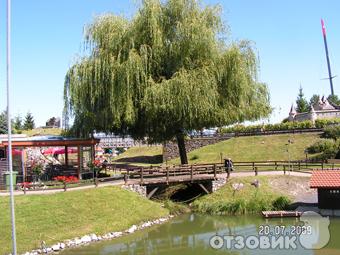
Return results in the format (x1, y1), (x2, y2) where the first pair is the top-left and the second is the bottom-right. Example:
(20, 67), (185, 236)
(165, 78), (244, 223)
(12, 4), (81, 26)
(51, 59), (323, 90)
(61, 214), (340, 255)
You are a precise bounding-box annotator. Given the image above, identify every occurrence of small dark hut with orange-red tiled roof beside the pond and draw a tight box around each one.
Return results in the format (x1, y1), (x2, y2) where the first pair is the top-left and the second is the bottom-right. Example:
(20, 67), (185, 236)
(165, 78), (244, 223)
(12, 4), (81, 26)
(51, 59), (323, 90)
(310, 170), (340, 209)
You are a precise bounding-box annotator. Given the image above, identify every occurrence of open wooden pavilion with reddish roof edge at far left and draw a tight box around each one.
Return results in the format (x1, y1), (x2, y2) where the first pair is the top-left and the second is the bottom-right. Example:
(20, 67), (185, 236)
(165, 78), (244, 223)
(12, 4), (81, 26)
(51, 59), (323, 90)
(0, 136), (99, 188)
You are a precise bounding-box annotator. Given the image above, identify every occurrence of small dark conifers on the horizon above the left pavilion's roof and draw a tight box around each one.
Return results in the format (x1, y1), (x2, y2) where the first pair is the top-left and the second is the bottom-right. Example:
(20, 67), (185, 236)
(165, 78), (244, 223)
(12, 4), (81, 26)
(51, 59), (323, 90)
(0, 111), (35, 134)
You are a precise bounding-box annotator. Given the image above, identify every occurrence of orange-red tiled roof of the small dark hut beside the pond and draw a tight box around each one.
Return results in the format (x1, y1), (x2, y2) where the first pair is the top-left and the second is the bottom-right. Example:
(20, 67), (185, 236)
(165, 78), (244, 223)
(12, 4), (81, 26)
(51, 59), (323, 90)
(309, 170), (340, 189)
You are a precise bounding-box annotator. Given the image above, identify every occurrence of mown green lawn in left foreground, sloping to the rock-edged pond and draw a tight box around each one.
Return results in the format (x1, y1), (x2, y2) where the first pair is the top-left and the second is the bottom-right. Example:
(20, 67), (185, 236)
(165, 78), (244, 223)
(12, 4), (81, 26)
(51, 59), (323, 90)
(0, 187), (168, 254)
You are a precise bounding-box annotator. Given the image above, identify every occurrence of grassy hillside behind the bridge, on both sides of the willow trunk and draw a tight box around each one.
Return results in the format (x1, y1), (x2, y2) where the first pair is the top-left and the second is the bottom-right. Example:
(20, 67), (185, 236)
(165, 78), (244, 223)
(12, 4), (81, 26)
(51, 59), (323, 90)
(116, 133), (320, 165)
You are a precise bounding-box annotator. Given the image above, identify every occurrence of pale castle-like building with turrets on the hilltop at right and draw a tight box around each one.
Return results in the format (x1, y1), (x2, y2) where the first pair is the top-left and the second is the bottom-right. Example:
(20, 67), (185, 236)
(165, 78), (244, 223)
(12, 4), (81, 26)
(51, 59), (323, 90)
(288, 97), (340, 122)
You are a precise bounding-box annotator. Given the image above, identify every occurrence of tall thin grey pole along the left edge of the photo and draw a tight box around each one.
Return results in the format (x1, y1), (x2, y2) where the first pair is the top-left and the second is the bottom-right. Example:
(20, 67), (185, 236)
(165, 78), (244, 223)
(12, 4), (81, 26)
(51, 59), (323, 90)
(6, 0), (17, 255)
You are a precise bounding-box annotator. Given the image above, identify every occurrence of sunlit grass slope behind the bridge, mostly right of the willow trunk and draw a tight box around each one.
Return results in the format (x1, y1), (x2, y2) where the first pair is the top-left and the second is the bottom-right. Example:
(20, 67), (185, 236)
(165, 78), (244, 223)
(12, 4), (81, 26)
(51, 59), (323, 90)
(169, 133), (320, 164)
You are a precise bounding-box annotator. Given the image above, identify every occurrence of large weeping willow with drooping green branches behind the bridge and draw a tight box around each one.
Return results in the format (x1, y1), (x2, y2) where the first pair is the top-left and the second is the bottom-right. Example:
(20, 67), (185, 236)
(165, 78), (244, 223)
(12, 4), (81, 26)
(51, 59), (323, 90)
(64, 0), (271, 164)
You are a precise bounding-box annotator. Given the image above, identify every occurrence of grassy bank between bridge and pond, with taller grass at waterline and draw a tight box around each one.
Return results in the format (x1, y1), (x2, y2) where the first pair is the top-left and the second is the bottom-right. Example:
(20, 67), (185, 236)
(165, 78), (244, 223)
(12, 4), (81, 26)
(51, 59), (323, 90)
(192, 176), (291, 214)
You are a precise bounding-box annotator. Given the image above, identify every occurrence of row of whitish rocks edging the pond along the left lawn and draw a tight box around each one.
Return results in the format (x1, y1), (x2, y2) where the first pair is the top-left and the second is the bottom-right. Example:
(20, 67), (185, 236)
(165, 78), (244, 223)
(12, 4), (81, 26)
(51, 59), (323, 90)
(14, 215), (175, 255)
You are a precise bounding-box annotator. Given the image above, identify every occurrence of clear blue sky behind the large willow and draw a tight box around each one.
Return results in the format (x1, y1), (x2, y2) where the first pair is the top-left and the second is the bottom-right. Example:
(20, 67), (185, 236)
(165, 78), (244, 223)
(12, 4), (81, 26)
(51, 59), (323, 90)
(0, 0), (340, 126)
